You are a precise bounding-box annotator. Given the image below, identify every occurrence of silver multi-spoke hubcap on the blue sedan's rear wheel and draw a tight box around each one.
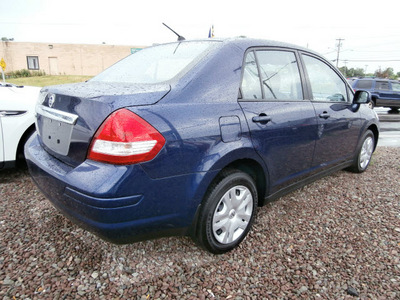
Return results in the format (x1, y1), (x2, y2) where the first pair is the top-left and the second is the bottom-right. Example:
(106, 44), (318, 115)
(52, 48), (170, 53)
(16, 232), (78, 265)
(212, 185), (253, 244)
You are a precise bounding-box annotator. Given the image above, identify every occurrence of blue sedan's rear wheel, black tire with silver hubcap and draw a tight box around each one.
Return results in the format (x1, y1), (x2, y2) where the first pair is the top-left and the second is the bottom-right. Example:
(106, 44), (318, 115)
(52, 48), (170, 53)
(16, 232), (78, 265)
(195, 170), (258, 254)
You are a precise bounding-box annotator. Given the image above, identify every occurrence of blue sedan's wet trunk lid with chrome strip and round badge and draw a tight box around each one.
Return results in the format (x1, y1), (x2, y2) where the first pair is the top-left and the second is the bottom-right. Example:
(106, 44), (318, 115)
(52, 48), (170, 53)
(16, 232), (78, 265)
(36, 82), (170, 166)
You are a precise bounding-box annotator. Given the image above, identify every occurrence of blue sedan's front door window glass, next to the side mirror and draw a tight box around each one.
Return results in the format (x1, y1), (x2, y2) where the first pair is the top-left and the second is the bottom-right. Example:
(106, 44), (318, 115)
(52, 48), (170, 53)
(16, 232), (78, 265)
(303, 55), (348, 102)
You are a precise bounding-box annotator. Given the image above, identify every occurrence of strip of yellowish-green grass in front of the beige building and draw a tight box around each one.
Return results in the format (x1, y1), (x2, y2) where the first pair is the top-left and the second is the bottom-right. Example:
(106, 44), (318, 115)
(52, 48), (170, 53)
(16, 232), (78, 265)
(7, 75), (93, 87)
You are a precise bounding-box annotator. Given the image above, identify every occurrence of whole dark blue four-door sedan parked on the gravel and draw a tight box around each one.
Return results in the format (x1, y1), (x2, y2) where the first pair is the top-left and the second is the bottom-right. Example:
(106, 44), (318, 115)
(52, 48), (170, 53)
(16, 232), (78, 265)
(25, 38), (379, 253)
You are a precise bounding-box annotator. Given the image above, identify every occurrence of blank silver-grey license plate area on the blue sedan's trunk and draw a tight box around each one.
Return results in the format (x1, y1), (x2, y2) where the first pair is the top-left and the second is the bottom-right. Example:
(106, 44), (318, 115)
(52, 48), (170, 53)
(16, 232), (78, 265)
(41, 116), (73, 155)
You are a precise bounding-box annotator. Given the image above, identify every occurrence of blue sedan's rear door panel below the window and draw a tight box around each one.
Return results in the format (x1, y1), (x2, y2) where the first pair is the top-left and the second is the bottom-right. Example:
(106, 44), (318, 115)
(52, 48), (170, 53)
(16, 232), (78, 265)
(240, 101), (317, 192)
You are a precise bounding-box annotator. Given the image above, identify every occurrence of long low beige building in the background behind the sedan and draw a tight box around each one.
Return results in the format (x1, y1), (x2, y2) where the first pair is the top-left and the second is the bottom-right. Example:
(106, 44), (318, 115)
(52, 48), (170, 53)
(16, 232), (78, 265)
(0, 41), (143, 76)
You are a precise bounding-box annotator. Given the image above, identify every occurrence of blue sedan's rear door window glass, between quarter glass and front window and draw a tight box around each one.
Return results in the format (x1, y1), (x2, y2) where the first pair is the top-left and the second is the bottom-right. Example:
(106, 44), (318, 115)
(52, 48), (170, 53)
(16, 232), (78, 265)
(257, 50), (303, 100)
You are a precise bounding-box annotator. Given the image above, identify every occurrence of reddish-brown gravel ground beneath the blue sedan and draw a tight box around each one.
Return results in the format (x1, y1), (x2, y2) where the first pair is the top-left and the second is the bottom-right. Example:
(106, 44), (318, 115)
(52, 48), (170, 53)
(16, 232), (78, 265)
(0, 147), (400, 299)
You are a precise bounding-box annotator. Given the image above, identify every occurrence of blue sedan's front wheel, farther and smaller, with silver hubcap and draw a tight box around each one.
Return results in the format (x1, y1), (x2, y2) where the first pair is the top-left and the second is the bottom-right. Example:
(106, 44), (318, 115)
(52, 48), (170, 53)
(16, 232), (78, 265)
(348, 130), (375, 173)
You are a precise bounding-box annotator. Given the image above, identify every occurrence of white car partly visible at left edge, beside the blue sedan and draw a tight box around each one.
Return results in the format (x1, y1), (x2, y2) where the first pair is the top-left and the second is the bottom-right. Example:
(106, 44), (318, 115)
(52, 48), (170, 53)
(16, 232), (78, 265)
(0, 82), (41, 169)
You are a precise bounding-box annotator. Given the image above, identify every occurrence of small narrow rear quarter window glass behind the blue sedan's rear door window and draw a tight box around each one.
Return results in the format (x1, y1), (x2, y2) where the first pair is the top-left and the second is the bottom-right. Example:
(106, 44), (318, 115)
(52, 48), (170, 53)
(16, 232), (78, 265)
(242, 52), (262, 99)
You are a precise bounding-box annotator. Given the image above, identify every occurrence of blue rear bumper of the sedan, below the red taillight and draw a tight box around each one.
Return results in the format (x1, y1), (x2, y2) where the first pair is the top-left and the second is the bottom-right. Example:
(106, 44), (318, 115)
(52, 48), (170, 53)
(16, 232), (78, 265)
(25, 136), (198, 244)
